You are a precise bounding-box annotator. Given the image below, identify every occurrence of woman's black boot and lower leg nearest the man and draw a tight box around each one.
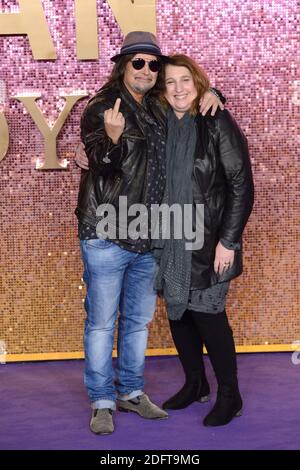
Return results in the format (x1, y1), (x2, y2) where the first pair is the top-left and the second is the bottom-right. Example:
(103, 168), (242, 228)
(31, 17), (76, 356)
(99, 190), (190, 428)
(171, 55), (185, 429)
(162, 311), (210, 410)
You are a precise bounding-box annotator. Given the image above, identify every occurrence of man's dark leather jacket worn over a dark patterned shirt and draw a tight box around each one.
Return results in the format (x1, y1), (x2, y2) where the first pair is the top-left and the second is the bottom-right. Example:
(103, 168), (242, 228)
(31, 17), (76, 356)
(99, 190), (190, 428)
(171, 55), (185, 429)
(75, 84), (165, 227)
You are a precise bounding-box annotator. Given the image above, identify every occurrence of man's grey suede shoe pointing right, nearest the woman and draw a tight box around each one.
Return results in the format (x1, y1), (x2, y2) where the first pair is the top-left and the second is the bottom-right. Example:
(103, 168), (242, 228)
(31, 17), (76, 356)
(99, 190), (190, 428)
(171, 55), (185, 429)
(117, 393), (168, 419)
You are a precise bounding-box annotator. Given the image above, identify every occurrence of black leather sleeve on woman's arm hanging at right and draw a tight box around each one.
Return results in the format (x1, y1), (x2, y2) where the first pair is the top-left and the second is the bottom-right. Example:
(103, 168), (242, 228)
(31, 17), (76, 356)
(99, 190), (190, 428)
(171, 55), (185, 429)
(217, 110), (254, 243)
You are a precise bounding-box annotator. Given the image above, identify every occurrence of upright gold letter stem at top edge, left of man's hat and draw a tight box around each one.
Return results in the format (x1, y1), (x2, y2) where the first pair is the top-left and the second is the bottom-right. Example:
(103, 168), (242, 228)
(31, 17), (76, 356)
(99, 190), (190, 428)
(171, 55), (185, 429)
(75, 0), (99, 60)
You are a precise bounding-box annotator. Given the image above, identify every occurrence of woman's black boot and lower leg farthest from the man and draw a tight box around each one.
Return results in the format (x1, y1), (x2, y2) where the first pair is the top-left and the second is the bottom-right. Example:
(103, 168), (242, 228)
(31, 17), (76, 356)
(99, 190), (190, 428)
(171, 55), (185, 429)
(191, 311), (243, 426)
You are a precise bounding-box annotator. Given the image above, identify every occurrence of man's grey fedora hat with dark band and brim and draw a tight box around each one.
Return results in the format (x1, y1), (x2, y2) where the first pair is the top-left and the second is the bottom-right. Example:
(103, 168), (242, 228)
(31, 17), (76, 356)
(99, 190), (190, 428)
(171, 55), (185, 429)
(111, 31), (168, 62)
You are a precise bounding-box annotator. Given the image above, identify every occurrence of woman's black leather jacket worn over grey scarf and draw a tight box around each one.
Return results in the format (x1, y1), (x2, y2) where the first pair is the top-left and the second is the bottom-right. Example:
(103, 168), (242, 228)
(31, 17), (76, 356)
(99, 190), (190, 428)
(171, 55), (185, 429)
(191, 110), (254, 289)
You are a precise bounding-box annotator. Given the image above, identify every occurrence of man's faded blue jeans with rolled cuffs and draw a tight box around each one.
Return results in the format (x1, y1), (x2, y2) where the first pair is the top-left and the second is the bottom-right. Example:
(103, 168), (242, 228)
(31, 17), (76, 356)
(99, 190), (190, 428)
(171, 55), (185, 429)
(80, 239), (157, 409)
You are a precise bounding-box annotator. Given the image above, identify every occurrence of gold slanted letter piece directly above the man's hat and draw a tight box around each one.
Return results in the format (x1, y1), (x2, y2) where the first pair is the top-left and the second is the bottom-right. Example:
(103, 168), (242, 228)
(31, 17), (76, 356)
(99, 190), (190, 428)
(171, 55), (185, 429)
(107, 0), (156, 34)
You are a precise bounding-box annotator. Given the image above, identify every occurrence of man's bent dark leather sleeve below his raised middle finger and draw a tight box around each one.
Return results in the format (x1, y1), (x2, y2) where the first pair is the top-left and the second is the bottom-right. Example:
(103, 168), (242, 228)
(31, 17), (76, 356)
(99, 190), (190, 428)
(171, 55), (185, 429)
(80, 100), (122, 176)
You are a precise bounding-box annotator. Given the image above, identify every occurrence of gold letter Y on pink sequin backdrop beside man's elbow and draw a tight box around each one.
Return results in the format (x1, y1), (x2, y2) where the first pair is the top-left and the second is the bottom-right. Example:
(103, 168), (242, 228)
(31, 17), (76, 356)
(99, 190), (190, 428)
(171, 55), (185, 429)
(14, 94), (87, 170)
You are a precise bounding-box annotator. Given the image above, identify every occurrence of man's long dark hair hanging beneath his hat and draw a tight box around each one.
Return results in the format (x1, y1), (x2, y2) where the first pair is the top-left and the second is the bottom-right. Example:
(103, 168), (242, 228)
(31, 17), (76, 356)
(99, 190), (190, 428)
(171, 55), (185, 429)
(99, 54), (164, 98)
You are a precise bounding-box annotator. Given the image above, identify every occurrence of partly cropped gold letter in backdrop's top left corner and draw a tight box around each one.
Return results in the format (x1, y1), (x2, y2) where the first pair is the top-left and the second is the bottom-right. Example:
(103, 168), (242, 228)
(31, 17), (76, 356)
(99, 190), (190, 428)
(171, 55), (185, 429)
(0, 0), (56, 60)
